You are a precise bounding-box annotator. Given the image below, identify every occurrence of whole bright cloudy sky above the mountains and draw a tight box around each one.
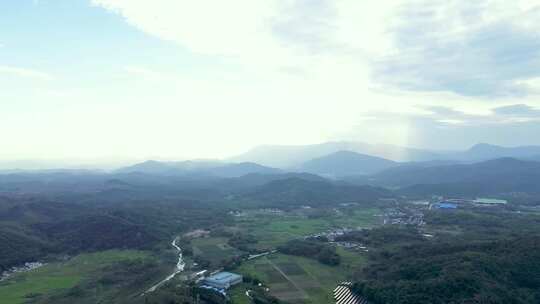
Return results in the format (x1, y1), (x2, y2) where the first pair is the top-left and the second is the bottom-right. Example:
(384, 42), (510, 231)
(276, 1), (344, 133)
(0, 0), (540, 166)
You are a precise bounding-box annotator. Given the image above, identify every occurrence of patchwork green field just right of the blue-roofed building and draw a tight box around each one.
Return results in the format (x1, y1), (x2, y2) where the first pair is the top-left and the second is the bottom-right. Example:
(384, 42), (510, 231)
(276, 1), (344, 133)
(233, 249), (365, 304)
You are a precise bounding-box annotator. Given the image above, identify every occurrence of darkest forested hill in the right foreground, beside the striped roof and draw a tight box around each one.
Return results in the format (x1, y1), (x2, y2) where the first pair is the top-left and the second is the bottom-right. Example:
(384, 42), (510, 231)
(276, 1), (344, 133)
(355, 237), (540, 304)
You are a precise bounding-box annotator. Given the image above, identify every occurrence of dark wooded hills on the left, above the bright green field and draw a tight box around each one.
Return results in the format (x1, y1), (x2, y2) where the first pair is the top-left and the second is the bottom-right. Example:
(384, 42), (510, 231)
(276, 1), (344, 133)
(0, 183), (227, 271)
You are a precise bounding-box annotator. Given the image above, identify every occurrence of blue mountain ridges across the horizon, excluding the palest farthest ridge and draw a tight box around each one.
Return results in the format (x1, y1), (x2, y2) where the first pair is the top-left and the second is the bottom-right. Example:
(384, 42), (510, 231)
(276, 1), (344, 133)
(0, 149), (540, 203)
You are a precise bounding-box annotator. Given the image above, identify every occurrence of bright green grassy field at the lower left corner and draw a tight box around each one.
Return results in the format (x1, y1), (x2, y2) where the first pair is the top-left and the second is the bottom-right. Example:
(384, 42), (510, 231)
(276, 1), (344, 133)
(0, 250), (148, 304)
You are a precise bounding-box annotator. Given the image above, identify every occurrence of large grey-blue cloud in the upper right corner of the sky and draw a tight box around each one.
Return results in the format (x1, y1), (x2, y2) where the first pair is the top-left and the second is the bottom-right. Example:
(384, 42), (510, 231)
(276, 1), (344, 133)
(375, 0), (540, 98)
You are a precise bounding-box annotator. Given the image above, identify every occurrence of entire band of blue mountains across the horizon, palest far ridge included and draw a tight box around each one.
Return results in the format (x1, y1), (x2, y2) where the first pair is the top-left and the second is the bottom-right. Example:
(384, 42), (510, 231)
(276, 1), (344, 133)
(6, 142), (540, 197)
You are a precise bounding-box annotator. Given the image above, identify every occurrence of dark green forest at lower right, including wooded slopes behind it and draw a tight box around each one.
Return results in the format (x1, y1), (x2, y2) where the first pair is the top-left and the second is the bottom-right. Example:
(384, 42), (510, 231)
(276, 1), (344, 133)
(352, 208), (540, 304)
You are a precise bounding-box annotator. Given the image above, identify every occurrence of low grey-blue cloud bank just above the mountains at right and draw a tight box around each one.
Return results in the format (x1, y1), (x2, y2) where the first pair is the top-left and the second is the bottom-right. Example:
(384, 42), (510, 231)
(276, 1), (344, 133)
(336, 104), (540, 150)
